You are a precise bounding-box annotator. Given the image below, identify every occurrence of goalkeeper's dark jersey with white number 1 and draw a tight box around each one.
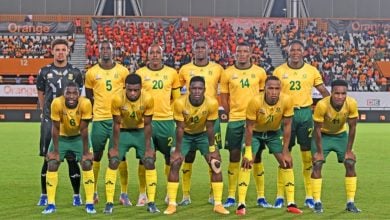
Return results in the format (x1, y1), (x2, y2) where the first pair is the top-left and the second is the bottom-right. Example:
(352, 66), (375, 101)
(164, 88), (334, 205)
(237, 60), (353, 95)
(37, 63), (84, 118)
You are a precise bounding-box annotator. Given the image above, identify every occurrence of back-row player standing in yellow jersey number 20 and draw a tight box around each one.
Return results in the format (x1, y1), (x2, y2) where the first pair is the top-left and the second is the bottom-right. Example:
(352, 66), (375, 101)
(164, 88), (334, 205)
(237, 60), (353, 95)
(136, 44), (180, 206)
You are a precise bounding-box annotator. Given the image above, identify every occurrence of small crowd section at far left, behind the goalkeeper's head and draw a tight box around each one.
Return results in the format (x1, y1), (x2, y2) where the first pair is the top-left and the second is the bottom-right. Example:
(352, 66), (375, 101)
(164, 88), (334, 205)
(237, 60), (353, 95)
(0, 35), (75, 58)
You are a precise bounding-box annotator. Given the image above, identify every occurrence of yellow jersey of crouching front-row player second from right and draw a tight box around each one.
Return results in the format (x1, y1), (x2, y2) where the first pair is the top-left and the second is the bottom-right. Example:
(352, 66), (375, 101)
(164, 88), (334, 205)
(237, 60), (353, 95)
(246, 93), (294, 132)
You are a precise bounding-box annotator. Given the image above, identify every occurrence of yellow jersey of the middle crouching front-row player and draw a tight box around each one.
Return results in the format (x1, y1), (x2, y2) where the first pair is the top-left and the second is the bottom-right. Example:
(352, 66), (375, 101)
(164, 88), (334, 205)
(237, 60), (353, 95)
(173, 95), (218, 134)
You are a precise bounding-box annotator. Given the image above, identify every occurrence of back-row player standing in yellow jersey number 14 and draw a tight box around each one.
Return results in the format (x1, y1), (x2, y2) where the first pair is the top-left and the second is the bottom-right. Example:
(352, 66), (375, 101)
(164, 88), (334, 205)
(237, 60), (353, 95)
(221, 43), (270, 207)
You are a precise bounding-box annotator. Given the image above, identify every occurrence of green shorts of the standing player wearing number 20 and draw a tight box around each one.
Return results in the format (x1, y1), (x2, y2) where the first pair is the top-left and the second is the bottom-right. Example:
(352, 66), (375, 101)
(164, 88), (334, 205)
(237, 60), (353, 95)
(152, 120), (176, 159)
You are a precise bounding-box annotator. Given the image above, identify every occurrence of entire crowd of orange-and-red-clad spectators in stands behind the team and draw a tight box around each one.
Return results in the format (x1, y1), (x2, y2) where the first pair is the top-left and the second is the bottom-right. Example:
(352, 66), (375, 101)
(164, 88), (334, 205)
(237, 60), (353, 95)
(0, 19), (390, 91)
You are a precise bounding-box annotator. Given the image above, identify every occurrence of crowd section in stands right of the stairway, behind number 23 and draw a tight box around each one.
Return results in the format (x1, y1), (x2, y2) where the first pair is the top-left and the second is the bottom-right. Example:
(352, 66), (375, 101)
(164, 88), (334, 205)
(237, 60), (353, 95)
(276, 20), (390, 91)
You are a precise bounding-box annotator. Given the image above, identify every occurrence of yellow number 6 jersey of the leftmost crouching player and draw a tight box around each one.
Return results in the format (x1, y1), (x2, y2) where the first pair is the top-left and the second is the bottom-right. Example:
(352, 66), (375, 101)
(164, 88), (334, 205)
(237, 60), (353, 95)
(50, 96), (92, 137)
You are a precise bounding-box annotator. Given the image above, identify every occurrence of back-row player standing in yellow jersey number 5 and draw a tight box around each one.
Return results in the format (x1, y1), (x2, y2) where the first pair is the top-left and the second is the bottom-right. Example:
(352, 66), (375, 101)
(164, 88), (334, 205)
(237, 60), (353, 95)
(85, 41), (131, 206)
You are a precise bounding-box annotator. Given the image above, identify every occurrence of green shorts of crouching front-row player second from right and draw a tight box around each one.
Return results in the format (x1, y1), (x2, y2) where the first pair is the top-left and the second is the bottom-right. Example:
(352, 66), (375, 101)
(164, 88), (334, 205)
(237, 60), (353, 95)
(247, 129), (283, 154)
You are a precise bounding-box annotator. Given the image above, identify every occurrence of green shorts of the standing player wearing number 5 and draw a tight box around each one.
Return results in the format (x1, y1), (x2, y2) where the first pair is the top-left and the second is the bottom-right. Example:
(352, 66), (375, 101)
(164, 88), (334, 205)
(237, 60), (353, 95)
(90, 119), (113, 152)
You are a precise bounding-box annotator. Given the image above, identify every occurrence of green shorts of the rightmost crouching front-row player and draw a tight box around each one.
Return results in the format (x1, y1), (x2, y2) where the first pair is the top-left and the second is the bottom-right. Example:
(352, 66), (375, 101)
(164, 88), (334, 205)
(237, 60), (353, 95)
(311, 131), (348, 163)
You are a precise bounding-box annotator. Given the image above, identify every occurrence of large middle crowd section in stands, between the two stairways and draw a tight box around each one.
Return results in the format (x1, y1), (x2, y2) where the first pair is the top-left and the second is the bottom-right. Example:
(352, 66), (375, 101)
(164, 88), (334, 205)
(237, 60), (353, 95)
(85, 20), (272, 73)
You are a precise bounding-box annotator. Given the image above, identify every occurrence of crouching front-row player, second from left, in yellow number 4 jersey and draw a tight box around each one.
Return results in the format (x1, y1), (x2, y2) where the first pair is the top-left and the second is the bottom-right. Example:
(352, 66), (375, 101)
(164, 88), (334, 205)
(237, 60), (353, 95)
(104, 74), (160, 214)
